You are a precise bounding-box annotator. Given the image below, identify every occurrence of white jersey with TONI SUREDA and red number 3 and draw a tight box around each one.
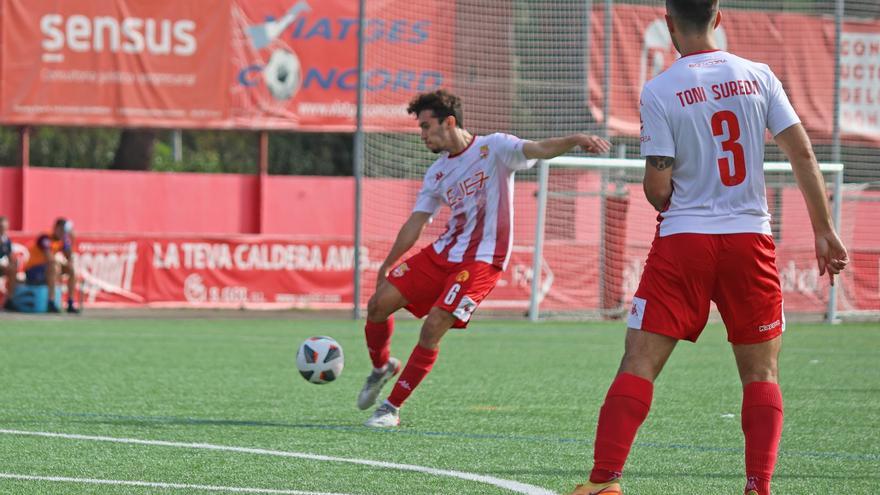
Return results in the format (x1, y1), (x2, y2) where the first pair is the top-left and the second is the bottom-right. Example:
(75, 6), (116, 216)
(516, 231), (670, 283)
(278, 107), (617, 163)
(641, 50), (800, 236)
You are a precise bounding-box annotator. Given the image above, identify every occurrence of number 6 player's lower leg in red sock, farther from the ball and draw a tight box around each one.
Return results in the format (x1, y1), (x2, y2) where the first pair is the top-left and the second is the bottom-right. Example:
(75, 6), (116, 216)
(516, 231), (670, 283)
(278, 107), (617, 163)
(365, 307), (456, 428)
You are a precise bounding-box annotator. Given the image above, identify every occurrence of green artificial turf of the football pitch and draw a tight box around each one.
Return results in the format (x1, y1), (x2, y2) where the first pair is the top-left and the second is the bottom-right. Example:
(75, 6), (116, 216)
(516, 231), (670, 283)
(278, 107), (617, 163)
(0, 318), (880, 495)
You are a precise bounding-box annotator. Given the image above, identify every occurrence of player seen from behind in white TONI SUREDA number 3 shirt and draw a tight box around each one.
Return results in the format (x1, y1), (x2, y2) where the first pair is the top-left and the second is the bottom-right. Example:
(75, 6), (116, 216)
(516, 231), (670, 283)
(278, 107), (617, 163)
(572, 0), (847, 495)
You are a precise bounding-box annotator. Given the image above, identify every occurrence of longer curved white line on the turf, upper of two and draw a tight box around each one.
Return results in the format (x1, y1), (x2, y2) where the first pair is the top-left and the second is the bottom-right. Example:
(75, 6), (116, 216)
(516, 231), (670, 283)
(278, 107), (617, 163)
(0, 429), (556, 495)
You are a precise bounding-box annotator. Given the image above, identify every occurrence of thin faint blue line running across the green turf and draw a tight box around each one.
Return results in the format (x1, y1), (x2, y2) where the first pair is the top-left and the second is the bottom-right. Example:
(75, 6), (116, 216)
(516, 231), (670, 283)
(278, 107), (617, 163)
(44, 411), (880, 462)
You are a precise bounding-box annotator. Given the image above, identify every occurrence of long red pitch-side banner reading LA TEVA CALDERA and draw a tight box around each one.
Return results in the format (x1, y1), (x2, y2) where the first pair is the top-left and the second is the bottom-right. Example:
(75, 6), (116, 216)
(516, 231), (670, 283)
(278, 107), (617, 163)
(2, 234), (379, 309)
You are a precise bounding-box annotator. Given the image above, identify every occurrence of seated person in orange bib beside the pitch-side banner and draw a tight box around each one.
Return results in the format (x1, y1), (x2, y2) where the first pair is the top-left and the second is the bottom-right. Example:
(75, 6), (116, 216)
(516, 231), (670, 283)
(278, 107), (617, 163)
(24, 218), (79, 313)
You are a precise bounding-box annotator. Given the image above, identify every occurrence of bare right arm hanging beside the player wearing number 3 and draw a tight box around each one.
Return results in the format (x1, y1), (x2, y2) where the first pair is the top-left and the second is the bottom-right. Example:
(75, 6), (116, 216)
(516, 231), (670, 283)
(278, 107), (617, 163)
(774, 124), (849, 285)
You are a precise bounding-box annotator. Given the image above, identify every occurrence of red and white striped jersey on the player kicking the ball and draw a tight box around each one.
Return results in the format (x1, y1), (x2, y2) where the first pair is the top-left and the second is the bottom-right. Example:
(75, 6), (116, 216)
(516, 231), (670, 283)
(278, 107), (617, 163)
(413, 133), (535, 270)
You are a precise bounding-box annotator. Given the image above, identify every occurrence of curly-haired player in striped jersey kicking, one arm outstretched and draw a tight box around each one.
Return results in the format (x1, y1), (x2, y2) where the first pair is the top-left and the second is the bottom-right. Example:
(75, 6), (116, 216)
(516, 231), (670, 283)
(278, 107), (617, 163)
(357, 90), (611, 427)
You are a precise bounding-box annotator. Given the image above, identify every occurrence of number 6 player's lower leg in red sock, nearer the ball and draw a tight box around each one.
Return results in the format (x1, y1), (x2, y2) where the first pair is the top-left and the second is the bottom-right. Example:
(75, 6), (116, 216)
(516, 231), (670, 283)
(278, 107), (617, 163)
(357, 282), (407, 410)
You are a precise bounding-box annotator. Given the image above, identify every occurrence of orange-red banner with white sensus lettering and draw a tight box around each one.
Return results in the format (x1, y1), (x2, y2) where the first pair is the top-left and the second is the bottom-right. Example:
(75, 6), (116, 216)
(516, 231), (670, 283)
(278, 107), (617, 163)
(0, 0), (231, 126)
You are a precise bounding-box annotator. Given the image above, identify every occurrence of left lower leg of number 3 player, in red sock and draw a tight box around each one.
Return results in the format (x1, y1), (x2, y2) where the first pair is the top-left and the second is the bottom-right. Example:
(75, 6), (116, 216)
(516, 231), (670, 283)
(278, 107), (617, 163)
(572, 328), (678, 495)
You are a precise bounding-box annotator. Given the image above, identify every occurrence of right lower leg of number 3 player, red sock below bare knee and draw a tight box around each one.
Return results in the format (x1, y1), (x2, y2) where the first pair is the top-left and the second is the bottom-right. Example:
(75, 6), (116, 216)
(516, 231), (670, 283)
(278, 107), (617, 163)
(733, 336), (783, 495)
